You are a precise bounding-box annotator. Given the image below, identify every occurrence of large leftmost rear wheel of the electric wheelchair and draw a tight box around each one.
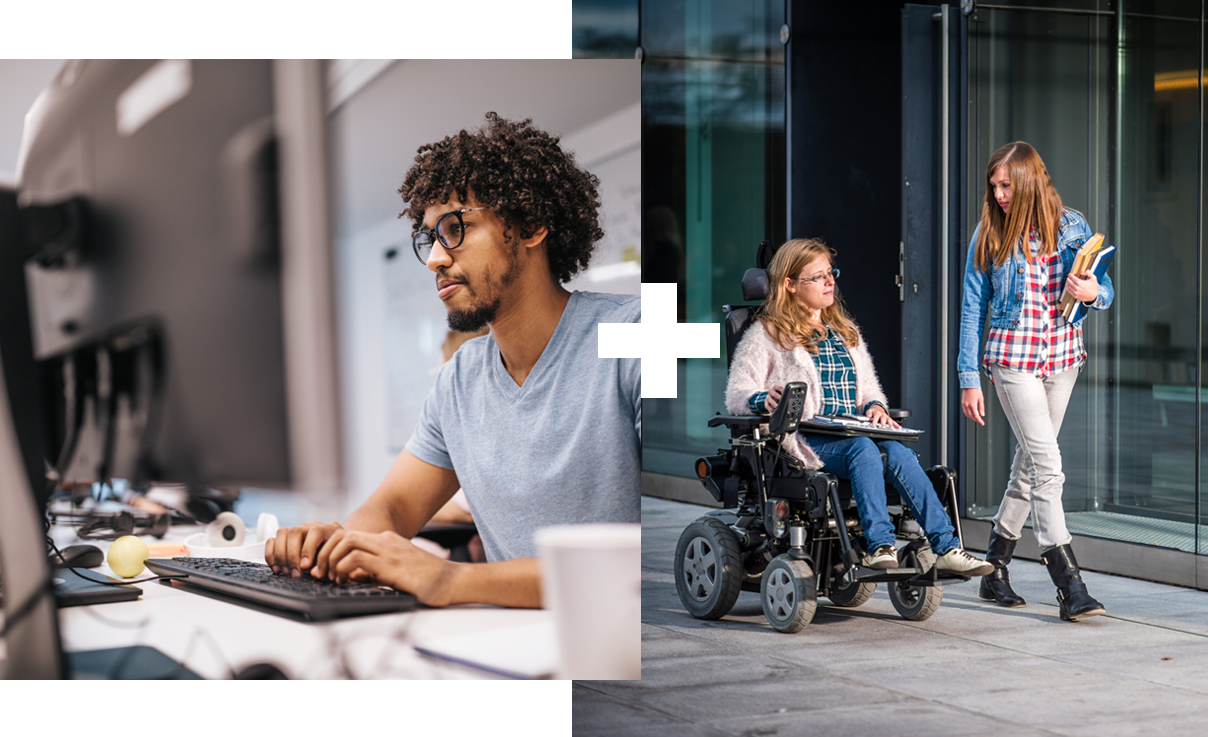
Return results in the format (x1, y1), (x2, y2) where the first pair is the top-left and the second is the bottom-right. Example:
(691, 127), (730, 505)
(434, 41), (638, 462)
(675, 517), (743, 620)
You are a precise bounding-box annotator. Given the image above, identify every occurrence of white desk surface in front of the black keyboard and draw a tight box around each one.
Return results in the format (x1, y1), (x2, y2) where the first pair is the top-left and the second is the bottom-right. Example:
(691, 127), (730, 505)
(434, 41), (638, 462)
(51, 527), (552, 679)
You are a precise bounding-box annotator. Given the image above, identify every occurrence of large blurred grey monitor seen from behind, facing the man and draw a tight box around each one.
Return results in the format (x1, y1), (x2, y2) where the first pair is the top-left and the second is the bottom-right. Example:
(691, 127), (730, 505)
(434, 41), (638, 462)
(0, 60), (343, 677)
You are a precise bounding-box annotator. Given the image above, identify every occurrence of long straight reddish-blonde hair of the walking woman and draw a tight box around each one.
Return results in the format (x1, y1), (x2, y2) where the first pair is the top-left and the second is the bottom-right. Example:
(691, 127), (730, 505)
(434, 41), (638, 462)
(975, 141), (1062, 273)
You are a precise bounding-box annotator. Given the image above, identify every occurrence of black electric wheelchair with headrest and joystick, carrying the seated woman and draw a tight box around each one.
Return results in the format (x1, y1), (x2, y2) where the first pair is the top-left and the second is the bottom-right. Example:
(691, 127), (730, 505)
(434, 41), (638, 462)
(675, 243), (969, 633)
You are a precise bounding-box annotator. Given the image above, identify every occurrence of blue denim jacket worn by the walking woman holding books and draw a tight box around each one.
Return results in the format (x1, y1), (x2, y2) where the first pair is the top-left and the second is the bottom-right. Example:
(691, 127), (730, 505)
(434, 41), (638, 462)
(957, 208), (1116, 389)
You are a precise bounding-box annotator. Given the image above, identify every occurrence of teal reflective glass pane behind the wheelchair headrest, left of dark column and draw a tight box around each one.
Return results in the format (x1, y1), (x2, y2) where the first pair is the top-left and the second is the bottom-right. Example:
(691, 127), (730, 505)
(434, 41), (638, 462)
(641, 0), (785, 476)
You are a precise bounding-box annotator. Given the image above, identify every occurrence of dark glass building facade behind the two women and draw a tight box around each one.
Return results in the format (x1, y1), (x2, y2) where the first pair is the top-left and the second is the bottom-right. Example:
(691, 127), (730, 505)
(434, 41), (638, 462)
(575, 0), (1208, 588)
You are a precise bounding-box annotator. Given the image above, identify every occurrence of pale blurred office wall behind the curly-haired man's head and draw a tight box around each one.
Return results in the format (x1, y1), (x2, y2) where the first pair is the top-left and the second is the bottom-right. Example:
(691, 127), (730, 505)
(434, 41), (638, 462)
(321, 59), (641, 511)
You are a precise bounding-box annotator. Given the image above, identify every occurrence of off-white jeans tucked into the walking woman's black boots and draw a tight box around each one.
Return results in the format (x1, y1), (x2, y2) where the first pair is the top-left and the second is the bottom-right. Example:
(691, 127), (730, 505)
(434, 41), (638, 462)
(991, 366), (1078, 551)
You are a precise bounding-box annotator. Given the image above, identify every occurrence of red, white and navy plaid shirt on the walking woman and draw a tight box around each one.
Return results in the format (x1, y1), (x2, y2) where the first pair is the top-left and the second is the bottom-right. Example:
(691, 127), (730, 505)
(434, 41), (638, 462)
(982, 232), (1086, 378)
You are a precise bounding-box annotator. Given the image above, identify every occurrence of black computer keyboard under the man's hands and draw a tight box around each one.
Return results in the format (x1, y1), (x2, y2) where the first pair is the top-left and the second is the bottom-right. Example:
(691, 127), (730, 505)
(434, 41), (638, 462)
(147, 558), (416, 621)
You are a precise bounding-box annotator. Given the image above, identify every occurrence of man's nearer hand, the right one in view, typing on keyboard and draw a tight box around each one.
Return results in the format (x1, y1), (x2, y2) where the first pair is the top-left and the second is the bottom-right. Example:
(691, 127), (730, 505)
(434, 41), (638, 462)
(310, 529), (457, 607)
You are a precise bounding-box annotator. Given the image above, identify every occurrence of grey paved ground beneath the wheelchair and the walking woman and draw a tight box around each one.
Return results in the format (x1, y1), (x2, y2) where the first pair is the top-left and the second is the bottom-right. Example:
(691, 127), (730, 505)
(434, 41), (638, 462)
(573, 497), (1208, 737)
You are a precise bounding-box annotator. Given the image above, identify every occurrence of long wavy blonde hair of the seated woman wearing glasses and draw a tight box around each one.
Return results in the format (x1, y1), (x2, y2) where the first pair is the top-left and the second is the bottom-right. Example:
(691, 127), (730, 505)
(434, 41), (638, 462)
(757, 238), (860, 354)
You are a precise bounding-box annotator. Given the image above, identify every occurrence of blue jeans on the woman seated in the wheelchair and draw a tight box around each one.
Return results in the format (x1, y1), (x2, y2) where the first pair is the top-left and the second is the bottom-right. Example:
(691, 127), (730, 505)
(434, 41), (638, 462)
(806, 435), (960, 556)
